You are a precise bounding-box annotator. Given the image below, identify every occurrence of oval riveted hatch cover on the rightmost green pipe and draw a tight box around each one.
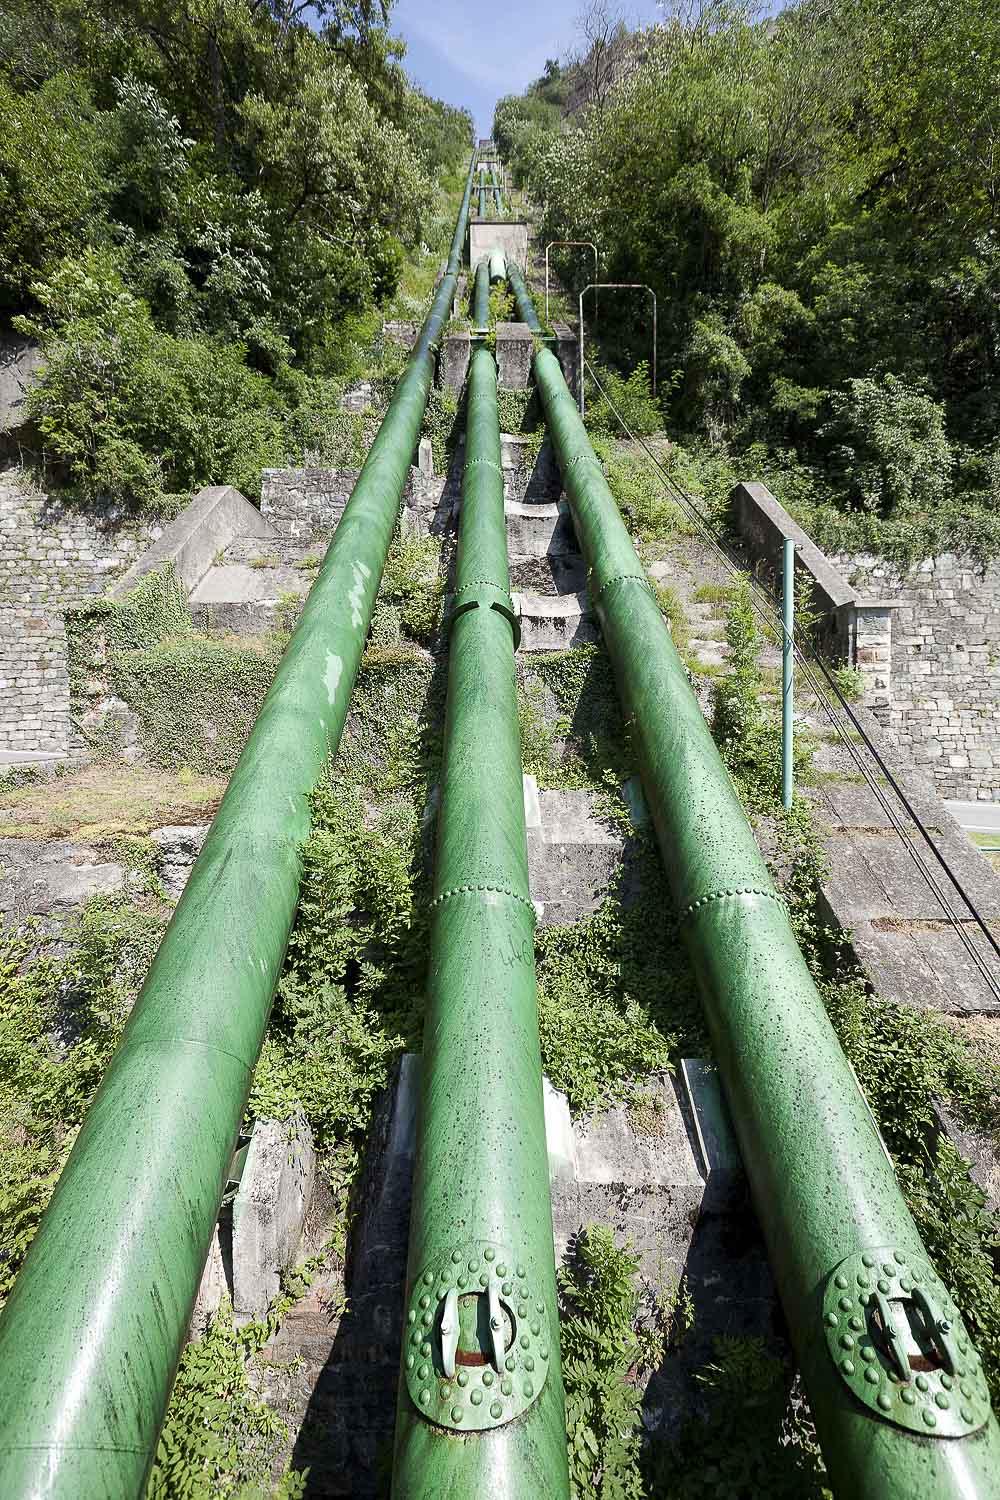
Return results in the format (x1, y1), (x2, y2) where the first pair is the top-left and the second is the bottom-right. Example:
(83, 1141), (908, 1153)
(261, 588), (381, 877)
(823, 1247), (991, 1437)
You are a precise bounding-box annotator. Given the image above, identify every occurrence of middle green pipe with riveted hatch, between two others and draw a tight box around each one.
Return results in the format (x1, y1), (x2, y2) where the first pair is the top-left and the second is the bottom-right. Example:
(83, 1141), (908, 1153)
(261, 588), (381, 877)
(393, 348), (568, 1500)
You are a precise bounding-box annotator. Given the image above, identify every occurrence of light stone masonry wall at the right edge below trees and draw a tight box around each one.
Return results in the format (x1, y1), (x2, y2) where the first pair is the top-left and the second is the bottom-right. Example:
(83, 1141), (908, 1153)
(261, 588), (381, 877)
(834, 552), (1000, 801)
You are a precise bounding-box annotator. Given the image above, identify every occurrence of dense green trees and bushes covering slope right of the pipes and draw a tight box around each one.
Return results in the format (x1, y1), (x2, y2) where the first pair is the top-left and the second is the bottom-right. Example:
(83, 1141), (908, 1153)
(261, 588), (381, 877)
(493, 0), (1000, 558)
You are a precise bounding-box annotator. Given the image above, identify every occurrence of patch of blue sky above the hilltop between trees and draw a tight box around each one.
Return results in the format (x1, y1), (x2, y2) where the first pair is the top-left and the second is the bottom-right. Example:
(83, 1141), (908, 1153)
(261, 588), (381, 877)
(390, 0), (660, 135)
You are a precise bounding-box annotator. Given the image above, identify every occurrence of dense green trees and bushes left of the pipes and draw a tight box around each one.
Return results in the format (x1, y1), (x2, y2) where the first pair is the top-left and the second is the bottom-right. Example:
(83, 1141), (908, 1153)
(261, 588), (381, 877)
(0, 0), (472, 503)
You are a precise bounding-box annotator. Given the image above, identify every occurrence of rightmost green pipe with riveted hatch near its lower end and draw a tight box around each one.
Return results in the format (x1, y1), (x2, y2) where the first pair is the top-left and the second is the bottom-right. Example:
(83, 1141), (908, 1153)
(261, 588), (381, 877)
(520, 313), (1000, 1500)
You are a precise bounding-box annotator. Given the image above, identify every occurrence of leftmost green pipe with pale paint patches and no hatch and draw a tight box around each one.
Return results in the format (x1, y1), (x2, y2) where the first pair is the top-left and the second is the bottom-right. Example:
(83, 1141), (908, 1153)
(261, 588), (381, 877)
(0, 155), (476, 1500)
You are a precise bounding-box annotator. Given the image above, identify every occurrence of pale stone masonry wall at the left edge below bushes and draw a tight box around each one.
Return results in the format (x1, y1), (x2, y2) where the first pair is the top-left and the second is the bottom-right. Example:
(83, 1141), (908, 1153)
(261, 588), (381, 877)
(0, 471), (162, 756)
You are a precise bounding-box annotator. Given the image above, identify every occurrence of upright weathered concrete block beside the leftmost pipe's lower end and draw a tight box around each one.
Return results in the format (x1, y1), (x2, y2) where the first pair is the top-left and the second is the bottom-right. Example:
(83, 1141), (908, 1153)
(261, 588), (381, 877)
(232, 1115), (316, 1319)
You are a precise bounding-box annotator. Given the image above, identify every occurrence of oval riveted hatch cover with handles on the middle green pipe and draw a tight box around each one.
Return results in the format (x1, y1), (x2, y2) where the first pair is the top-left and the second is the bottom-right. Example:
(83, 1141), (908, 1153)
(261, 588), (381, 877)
(403, 1239), (555, 1433)
